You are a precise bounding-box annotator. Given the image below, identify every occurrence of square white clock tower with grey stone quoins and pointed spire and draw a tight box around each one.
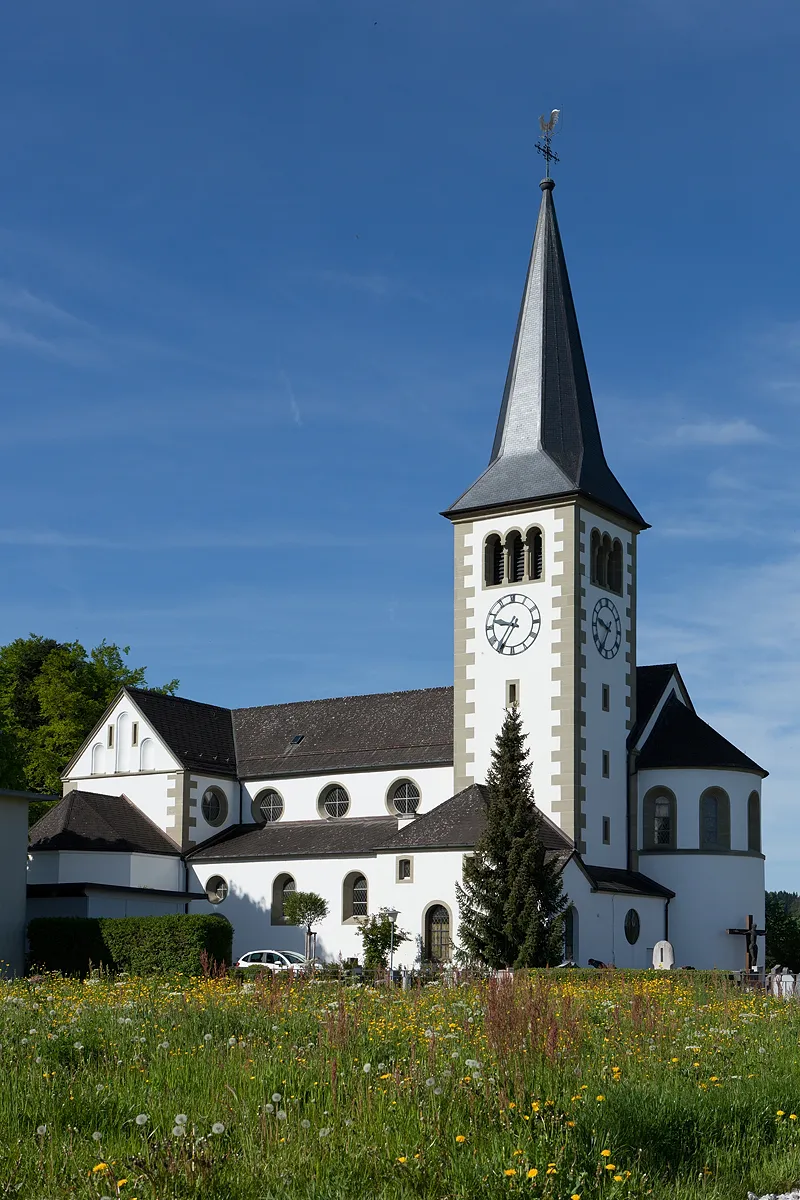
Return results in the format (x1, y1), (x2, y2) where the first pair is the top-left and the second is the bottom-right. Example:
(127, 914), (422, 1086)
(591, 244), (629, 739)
(444, 179), (648, 866)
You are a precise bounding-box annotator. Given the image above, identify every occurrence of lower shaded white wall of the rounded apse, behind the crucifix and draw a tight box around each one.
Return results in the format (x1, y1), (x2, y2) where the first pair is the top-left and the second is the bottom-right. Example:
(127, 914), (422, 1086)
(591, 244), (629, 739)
(640, 853), (764, 971)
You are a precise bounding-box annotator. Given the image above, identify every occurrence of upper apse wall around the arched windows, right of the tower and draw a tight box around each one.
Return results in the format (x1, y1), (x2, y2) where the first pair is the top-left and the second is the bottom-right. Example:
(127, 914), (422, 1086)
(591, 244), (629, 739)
(637, 769), (762, 854)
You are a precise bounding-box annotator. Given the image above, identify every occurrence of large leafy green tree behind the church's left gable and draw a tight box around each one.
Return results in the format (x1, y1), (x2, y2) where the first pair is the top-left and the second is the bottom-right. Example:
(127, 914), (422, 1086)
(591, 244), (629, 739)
(0, 634), (178, 820)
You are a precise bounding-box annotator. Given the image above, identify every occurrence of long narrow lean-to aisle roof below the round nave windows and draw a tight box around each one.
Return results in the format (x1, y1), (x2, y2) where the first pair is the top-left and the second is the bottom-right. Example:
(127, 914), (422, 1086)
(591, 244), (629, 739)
(187, 816), (397, 862)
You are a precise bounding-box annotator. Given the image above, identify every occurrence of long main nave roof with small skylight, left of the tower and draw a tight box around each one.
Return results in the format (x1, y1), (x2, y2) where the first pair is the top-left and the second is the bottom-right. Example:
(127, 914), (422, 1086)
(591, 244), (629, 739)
(233, 688), (453, 779)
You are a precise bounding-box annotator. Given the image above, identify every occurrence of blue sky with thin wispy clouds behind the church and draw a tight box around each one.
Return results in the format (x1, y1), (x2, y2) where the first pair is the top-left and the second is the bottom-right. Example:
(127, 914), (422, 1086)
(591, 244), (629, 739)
(0, 0), (800, 890)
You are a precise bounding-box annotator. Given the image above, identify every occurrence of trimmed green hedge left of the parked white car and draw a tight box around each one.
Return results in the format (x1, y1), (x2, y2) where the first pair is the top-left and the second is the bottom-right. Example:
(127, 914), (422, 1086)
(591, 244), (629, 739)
(28, 913), (234, 976)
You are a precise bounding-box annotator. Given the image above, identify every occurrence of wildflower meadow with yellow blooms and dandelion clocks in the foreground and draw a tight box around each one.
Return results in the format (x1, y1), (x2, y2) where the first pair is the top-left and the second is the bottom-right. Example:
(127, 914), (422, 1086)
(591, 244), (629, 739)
(0, 971), (800, 1200)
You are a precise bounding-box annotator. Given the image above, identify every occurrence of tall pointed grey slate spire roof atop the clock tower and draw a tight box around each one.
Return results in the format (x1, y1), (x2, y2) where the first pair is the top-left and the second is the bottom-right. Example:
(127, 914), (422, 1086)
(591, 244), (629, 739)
(445, 179), (646, 528)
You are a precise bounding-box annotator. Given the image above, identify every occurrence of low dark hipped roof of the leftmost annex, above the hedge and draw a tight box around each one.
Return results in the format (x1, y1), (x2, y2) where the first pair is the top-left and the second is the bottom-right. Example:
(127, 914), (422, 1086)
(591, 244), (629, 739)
(29, 792), (180, 854)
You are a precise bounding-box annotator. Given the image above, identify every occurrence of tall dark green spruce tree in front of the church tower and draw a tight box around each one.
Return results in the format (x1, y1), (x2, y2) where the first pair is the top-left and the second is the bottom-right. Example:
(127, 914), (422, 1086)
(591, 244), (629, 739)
(456, 706), (570, 970)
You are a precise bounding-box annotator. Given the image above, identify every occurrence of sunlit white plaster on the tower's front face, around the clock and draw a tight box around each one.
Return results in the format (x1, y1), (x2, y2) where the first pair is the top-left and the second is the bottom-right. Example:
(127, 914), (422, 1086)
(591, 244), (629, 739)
(455, 509), (564, 821)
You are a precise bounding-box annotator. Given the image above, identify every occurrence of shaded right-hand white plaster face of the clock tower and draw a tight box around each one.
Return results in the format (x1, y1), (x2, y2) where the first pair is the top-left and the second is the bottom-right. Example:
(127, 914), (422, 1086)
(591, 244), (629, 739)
(579, 506), (636, 866)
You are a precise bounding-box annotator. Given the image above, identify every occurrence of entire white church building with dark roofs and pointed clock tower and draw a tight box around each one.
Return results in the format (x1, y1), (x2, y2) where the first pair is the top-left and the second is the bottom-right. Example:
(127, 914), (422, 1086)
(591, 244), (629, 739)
(28, 179), (766, 970)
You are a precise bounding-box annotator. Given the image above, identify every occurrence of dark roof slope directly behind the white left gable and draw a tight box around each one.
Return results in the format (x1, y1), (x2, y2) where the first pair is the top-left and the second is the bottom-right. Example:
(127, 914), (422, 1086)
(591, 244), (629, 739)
(127, 688), (236, 775)
